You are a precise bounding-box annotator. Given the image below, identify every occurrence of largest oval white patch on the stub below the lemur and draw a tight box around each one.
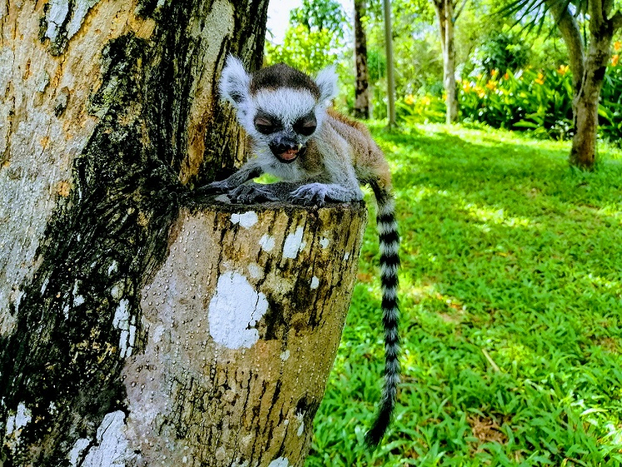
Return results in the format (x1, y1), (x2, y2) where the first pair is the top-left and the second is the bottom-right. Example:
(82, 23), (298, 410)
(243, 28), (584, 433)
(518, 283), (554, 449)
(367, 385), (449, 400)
(208, 272), (268, 349)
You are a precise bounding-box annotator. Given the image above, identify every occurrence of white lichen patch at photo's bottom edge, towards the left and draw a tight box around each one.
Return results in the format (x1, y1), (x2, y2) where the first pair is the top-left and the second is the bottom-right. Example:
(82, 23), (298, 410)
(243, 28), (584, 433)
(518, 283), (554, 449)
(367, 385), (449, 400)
(80, 410), (136, 467)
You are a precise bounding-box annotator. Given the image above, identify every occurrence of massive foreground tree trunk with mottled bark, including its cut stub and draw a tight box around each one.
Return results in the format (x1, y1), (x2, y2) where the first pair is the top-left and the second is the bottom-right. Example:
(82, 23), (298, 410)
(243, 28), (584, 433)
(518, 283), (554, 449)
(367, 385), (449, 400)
(0, 0), (362, 467)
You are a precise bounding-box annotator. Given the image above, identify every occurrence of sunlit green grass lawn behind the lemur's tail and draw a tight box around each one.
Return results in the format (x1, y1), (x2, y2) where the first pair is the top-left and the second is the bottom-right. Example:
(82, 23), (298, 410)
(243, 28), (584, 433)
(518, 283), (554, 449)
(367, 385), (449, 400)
(306, 125), (622, 467)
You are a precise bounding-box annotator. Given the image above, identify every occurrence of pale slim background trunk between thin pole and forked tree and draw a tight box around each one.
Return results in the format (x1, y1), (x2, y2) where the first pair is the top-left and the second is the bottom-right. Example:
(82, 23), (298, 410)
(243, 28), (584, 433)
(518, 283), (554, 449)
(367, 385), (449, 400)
(434, 0), (458, 125)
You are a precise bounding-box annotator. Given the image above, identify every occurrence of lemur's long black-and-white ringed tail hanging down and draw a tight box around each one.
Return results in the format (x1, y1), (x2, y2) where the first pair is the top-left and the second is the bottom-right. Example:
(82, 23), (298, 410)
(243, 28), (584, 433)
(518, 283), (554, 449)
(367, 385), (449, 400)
(365, 183), (400, 446)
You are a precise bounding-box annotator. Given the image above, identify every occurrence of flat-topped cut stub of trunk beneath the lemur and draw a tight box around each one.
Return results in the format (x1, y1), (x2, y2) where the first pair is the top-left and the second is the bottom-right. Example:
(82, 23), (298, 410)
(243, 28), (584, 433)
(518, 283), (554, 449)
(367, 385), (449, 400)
(120, 203), (366, 467)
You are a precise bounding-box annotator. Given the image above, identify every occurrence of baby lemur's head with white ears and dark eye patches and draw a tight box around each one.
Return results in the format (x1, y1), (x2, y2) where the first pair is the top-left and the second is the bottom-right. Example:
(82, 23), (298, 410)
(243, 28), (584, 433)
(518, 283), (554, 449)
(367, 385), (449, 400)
(220, 56), (337, 164)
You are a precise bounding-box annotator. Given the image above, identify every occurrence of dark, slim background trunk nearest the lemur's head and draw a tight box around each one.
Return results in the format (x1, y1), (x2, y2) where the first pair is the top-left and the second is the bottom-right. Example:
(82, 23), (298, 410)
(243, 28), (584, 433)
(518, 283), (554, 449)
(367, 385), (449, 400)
(354, 0), (370, 120)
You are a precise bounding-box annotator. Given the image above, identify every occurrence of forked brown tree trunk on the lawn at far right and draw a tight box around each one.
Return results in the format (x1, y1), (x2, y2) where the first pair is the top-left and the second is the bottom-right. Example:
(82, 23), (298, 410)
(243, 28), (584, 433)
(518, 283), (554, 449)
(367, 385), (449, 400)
(546, 0), (622, 170)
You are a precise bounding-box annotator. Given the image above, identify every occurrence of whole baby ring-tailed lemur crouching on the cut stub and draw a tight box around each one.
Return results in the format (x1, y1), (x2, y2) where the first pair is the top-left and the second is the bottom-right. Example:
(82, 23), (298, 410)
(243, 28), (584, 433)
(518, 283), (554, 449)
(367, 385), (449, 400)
(199, 56), (400, 446)
